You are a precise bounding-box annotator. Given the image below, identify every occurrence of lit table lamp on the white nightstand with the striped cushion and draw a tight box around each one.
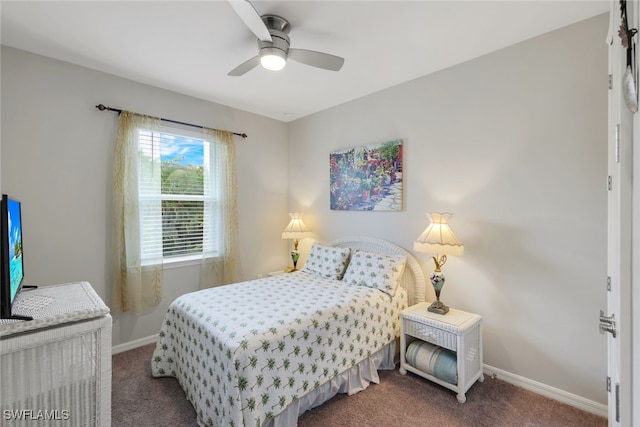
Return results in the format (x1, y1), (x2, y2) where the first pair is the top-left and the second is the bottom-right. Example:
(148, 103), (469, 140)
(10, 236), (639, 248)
(413, 212), (464, 314)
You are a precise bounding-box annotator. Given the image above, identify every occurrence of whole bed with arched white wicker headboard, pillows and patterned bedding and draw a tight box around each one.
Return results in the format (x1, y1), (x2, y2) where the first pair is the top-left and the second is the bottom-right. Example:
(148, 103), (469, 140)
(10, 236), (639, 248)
(151, 237), (425, 427)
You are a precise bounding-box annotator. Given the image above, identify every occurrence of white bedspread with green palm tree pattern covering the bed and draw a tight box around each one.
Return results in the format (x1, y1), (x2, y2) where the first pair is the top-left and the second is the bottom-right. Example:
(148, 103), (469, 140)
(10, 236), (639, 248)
(152, 271), (406, 427)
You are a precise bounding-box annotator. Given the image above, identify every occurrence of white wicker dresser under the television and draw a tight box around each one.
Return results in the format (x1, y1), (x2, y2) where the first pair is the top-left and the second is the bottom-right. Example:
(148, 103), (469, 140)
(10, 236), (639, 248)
(0, 282), (111, 427)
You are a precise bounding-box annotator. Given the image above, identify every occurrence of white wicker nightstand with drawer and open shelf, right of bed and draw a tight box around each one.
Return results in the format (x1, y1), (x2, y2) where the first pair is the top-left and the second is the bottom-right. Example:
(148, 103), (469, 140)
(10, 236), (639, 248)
(400, 302), (484, 403)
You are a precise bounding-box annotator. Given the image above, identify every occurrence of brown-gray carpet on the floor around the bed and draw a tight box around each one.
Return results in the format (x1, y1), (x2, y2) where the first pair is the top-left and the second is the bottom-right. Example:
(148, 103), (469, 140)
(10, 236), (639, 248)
(111, 344), (607, 427)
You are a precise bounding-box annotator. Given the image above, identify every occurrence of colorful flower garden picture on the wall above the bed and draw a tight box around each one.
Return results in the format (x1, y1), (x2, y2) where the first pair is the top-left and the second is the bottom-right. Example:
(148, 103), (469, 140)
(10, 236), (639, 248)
(329, 139), (404, 211)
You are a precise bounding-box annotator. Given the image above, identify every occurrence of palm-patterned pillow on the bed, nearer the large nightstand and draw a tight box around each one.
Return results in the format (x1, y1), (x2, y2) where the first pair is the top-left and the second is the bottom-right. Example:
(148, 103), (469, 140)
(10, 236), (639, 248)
(344, 251), (407, 296)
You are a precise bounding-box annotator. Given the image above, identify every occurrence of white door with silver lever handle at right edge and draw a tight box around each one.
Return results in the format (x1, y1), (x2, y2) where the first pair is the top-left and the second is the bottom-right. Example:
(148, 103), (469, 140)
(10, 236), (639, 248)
(599, 1), (640, 427)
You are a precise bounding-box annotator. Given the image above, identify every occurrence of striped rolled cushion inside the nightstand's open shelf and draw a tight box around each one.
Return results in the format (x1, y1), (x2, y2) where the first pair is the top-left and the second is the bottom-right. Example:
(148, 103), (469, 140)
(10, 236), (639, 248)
(405, 340), (458, 384)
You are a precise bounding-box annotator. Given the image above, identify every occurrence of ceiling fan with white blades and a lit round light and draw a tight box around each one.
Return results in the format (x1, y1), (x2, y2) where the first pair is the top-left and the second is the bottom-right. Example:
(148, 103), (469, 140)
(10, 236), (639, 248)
(227, 0), (344, 76)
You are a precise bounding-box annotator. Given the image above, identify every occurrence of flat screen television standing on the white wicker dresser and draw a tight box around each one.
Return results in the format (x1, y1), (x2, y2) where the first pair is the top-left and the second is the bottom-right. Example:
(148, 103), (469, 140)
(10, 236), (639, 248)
(0, 194), (33, 320)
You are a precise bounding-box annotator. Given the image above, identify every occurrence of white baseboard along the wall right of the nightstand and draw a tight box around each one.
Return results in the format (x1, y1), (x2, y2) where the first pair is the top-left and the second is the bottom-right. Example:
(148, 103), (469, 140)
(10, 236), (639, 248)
(483, 364), (608, 418)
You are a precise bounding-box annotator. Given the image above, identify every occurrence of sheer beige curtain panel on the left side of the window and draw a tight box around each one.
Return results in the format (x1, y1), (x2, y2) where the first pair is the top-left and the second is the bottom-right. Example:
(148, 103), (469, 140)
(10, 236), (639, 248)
(111, 111), (163, 314)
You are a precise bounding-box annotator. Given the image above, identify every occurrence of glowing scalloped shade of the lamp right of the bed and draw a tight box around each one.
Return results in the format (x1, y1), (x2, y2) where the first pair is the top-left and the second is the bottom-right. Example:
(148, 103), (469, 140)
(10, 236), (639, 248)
(413, 212), (464, 255)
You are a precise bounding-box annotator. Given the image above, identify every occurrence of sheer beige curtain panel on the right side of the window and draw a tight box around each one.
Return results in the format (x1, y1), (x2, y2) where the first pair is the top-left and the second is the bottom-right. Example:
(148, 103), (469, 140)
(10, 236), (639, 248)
(200, 128), (239, 289)
